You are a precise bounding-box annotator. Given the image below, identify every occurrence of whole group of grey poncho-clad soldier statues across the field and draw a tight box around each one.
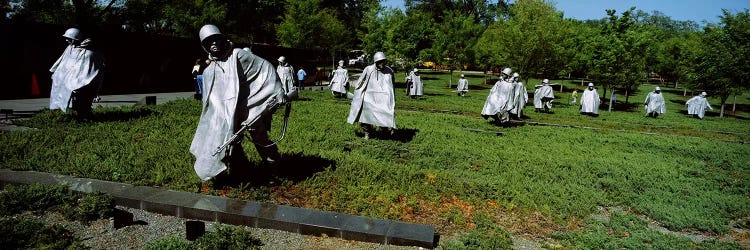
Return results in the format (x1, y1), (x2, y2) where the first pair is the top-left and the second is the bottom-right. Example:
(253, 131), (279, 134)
(45, 24), (711, 181)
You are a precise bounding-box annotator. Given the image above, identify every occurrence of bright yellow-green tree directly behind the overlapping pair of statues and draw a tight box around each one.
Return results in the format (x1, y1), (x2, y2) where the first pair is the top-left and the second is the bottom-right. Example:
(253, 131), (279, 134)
(476, 0), (566, 80)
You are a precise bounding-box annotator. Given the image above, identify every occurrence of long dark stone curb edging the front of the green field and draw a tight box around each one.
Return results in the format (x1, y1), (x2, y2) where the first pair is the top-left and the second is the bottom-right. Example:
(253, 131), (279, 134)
(0, 169), (439, 248)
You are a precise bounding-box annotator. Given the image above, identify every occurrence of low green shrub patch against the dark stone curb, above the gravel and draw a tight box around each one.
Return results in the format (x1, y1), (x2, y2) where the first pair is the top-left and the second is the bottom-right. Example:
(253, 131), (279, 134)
(0, 183), (114, 222)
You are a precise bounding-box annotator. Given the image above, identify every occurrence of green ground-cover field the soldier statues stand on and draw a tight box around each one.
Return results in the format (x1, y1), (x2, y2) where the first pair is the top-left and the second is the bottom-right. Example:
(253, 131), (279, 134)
(0, 71), (750, 249)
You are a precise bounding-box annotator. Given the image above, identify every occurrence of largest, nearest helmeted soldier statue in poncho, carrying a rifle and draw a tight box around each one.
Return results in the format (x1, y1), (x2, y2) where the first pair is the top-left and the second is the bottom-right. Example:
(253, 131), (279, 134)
(190, 25), (285, 181)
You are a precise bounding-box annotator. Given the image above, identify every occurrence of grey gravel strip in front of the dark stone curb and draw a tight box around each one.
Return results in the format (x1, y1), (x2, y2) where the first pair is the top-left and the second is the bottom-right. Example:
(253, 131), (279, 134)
(19, 206), (420, 250)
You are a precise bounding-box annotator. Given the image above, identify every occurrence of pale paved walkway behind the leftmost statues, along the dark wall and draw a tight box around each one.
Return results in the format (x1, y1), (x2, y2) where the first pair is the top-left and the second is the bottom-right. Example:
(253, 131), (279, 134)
(0, 92), (198, 113)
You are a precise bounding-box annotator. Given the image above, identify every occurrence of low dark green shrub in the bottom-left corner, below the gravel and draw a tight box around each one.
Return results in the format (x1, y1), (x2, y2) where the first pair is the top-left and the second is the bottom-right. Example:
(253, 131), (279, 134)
(0, 218), (87, 250)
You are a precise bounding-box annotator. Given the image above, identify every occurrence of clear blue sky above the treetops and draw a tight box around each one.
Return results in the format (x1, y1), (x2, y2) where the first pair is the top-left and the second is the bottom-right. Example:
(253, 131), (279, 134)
(383, 0), (750, 24)
